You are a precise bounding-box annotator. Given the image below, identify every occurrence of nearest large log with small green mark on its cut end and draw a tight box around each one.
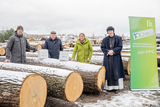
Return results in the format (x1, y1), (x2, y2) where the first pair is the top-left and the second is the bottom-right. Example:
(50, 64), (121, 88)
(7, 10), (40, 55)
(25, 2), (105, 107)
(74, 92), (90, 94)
(0, 70), (47, 107)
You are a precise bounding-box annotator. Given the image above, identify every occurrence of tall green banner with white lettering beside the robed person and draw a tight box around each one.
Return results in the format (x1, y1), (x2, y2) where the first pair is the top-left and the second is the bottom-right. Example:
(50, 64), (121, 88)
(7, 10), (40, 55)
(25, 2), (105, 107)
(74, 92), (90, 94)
(129, 17), (159, 89)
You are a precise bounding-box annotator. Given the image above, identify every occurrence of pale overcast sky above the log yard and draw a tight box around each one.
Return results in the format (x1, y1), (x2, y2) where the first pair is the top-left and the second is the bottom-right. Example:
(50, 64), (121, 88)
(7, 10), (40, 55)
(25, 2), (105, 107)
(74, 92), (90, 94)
(0, 0), (160, 35)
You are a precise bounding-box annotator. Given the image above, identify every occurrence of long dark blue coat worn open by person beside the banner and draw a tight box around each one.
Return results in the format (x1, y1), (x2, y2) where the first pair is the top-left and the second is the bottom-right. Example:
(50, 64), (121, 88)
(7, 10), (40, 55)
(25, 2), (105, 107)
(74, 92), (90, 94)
(101, 35), (125, 80)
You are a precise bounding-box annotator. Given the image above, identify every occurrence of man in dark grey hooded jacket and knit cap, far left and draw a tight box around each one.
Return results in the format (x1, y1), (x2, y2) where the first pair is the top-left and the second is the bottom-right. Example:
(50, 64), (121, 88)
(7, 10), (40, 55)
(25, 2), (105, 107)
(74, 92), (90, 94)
(5, 26), (37, 63)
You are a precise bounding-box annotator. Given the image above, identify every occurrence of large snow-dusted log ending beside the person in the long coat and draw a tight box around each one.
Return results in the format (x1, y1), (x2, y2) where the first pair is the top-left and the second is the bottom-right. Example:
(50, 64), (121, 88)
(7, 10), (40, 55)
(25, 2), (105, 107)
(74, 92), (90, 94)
(27, 57), (106, 93)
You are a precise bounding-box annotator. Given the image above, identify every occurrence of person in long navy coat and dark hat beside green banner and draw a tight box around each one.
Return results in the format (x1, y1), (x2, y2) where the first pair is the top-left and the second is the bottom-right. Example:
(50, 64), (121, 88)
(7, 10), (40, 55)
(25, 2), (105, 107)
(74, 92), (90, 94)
(101, 26), (125, 93)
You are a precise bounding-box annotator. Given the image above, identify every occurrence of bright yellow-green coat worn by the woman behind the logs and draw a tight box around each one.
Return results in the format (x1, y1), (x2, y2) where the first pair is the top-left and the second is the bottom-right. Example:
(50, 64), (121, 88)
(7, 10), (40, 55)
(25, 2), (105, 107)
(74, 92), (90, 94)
(72, 38), (93, 63)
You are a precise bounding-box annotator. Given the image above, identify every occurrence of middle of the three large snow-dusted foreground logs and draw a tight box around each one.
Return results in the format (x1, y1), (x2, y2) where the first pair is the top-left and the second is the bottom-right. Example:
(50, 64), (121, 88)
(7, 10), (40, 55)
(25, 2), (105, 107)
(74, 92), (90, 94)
(0, 62), (83, 102)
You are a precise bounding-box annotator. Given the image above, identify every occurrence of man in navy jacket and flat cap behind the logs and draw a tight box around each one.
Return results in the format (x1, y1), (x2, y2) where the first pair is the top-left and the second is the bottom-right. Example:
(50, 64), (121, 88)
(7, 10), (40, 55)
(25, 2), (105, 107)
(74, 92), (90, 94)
(44, 31), (63, 59)
